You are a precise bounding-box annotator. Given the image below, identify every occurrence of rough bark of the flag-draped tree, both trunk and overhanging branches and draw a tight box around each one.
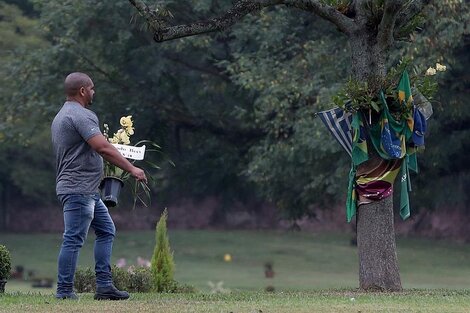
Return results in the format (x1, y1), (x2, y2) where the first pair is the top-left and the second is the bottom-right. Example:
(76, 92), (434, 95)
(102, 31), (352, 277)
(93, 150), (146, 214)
(129, 0), (429, 291)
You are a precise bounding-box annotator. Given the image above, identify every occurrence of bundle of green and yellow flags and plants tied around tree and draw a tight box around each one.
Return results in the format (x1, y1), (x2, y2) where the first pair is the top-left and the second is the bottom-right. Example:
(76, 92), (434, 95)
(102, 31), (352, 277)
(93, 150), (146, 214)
(326, 59), (446, 222)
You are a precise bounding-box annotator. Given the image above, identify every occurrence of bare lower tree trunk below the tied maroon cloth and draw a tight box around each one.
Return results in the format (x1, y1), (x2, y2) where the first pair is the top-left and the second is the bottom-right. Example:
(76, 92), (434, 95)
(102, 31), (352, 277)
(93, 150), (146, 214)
(357, 197), (402, 291)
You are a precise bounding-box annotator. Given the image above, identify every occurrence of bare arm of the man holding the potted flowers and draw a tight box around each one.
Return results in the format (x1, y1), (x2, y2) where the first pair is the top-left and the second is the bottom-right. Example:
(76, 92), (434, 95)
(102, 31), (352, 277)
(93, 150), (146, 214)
(87, 134), (147, 182)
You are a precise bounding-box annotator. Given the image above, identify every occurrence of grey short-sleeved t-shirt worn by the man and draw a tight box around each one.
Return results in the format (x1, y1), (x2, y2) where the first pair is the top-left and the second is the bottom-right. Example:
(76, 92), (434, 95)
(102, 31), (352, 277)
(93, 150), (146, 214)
(51, 101), (103, 195)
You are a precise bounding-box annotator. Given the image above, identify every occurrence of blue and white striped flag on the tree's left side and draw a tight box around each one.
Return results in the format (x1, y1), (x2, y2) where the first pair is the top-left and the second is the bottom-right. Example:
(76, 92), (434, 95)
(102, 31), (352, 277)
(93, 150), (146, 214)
(317, 108), (352, 156)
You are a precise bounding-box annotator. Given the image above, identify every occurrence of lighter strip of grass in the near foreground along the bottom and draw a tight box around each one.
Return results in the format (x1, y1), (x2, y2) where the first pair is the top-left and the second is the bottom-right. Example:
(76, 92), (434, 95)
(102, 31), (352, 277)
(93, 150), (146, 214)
(0, 289), (470, 313)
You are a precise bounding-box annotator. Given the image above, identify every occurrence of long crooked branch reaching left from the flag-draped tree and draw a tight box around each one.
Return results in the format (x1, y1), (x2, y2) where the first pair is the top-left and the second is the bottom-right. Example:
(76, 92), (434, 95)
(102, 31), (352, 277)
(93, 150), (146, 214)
(129, 0), (354, 42)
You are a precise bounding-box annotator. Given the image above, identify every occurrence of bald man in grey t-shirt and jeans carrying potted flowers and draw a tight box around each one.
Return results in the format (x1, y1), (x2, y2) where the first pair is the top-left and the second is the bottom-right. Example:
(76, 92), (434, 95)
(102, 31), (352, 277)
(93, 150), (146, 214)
(51, 72), (147, 300)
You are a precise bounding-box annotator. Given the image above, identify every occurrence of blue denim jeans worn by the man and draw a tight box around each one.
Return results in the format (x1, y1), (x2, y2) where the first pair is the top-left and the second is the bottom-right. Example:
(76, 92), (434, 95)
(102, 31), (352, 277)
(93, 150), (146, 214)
(57, 194), (116, 295)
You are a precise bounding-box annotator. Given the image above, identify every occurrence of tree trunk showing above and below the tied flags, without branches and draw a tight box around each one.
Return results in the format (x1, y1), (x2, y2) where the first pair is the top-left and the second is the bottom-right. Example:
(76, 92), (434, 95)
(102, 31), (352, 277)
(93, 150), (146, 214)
(350, 28), (402, 291)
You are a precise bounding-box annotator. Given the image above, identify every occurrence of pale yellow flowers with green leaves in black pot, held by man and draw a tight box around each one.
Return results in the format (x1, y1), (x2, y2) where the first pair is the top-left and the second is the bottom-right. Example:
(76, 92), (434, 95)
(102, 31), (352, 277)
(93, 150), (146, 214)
(101, 115), (160, 207)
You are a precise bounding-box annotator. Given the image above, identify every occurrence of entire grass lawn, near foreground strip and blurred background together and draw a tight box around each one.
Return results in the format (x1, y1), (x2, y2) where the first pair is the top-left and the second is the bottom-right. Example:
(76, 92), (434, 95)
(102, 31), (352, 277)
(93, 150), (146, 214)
(0, 230), (470, 313)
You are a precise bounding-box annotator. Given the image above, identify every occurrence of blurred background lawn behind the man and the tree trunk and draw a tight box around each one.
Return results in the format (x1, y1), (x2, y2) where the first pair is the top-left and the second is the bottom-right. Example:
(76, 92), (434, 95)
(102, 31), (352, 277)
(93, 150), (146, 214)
(0, 230), (470, 292)
